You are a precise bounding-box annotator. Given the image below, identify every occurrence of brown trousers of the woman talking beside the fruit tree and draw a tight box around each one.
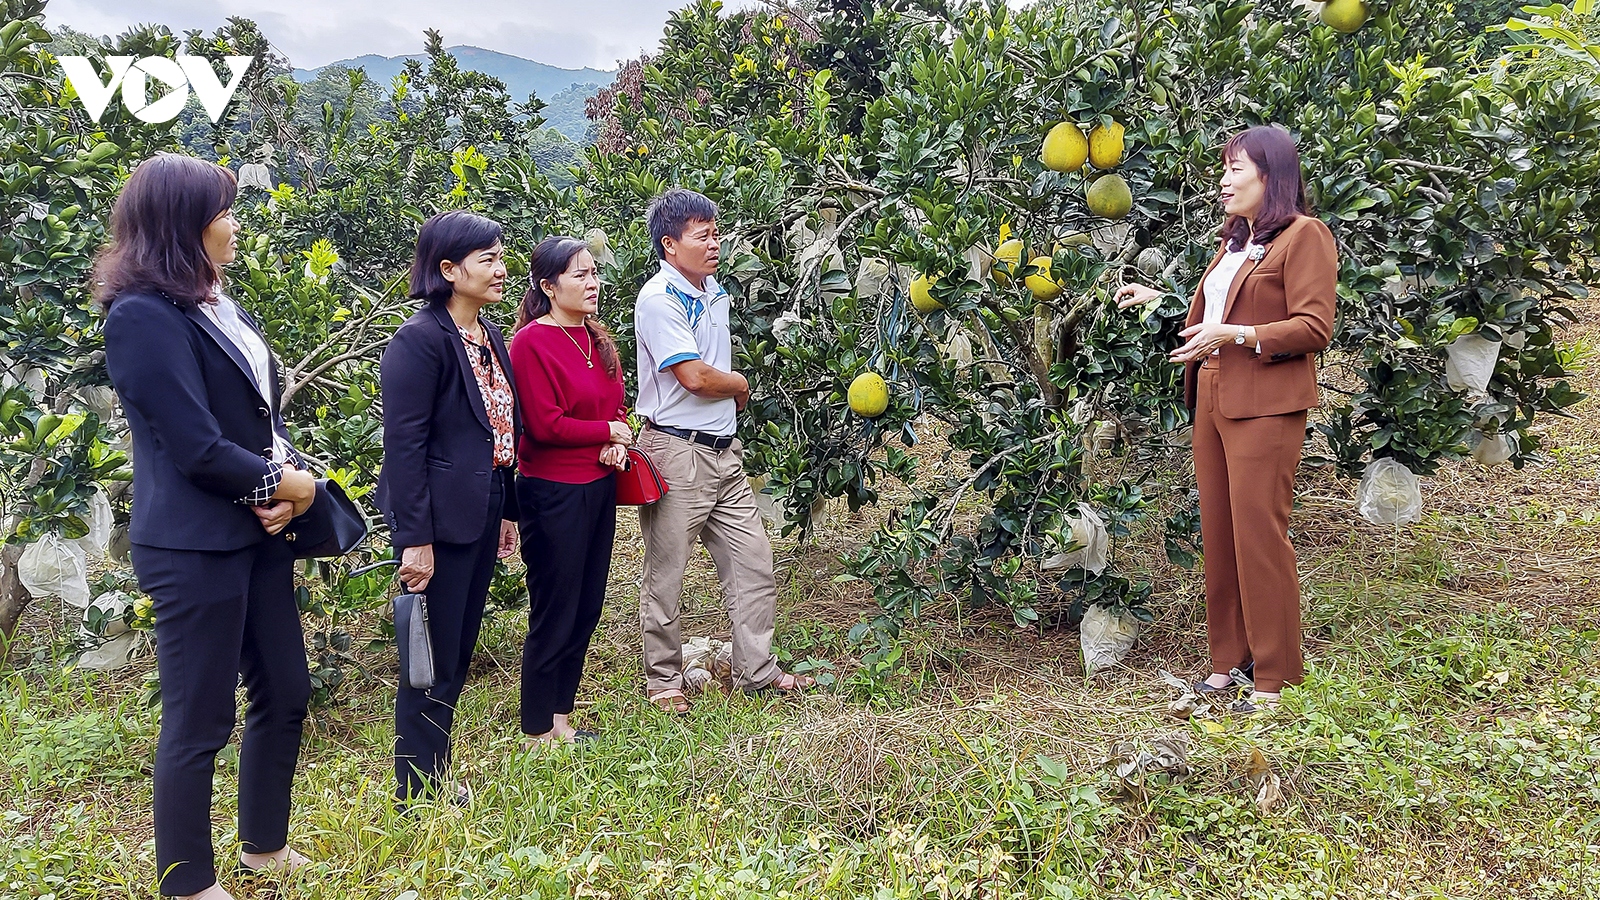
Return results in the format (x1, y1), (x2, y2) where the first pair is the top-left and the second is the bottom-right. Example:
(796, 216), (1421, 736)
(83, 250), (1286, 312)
(1194, 364), (1306, 692)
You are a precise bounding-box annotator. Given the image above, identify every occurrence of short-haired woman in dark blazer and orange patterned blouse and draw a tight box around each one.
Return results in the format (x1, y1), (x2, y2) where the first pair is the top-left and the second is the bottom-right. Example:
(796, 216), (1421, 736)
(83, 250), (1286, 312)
(376, 211), (520, 802)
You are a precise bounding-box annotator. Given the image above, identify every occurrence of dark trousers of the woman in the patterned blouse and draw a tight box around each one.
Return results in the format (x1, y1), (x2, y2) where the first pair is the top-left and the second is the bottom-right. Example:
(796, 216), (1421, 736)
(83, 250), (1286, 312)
(395, 477), (504, 801)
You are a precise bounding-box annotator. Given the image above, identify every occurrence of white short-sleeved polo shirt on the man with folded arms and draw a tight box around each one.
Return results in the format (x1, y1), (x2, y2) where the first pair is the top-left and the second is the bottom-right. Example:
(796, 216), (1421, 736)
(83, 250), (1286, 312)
(634, 259), (739, 437)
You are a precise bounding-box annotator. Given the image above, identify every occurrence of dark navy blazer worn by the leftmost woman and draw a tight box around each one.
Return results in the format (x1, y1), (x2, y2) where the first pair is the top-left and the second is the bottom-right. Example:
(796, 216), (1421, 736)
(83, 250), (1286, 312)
(104, 293), (300, 551)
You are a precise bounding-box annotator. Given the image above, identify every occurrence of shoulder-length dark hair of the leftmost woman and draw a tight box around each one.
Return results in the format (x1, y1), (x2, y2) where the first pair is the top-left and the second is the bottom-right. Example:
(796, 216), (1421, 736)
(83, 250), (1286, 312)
(94, 154), (238, 309)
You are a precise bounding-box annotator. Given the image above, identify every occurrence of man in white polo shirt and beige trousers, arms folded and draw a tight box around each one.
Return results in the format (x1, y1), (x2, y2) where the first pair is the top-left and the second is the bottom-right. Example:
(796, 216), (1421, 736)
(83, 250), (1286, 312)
(634, 187), (816, 714)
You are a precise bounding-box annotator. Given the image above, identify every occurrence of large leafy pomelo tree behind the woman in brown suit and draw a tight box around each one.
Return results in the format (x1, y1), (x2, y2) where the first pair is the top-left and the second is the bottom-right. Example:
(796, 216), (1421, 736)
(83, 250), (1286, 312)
(574, 0), (1600, 636)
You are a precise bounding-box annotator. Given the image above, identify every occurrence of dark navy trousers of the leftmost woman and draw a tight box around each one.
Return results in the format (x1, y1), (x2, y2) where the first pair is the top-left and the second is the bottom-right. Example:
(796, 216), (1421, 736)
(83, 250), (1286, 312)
(133, 536), (310, 895)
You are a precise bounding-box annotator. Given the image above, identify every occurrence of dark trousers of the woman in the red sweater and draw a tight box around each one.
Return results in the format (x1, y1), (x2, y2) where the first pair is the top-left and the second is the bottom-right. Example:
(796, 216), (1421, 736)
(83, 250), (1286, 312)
(517, 476), (616, 735)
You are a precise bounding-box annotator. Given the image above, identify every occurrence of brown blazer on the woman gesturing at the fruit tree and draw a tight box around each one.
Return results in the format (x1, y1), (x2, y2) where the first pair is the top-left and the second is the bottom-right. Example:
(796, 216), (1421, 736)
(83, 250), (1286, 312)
(1184, 216), (1339, 418)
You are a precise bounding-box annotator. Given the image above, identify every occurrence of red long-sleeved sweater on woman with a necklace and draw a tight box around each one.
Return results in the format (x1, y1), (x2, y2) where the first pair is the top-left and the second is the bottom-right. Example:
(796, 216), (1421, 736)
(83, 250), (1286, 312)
(510, 322), (627, 484)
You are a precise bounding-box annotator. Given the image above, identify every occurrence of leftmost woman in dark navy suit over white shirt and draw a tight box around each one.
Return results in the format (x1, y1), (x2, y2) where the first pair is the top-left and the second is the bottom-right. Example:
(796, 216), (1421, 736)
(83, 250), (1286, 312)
(96, 154), (315, 900)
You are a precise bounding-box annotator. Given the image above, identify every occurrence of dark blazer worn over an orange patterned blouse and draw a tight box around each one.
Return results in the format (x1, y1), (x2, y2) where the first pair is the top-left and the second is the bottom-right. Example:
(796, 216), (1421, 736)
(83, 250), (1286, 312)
(376, 304), (522, 548)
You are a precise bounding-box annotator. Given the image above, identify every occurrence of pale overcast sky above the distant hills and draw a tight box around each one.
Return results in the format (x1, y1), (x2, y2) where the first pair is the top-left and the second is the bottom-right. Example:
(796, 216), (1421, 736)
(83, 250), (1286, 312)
(46, 0), (755, 69)
